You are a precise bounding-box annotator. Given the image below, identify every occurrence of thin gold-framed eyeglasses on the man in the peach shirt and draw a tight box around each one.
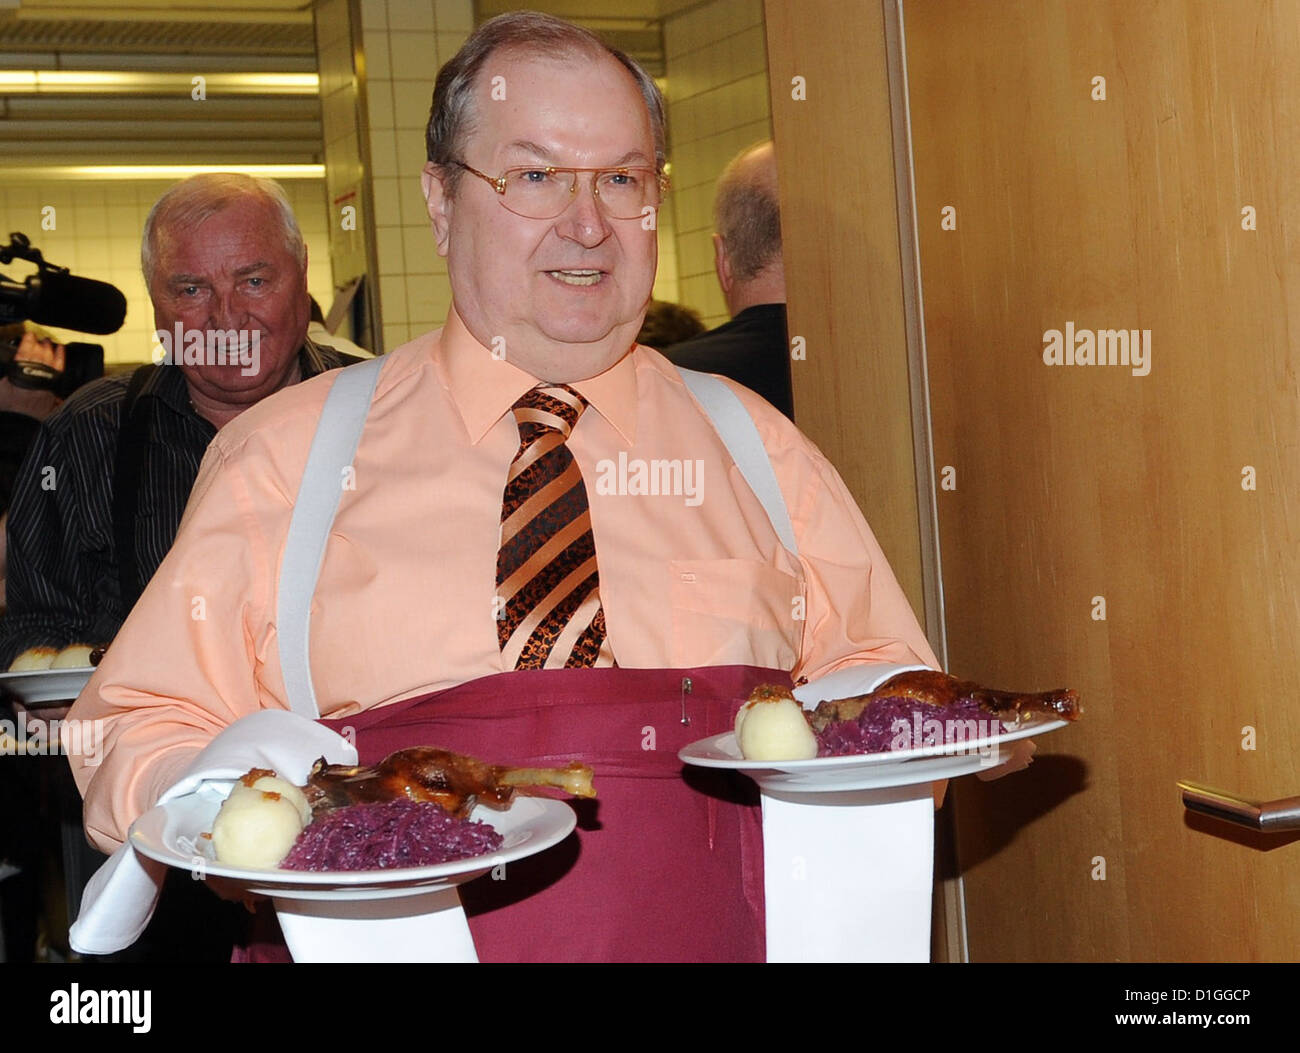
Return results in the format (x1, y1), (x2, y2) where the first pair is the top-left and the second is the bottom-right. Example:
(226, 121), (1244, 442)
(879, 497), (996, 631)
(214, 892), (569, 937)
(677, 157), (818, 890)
(450, 161), (668, 220)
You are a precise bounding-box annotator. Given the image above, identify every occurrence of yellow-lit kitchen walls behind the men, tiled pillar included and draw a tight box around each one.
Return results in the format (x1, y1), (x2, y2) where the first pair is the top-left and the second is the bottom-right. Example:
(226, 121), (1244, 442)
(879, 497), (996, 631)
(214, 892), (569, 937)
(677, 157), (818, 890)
(0, 0), (771, 363)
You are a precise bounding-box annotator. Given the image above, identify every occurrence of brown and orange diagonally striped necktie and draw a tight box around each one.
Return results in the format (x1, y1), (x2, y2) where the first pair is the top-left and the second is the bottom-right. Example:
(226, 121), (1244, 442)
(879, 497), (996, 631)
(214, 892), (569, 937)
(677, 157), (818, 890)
(497, 385), (615, 670)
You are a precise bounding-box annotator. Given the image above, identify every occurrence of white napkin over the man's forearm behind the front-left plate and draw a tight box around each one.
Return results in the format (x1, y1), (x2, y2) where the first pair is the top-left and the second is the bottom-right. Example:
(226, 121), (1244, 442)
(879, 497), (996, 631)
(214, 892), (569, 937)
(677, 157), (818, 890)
(69, 710), (356, 954)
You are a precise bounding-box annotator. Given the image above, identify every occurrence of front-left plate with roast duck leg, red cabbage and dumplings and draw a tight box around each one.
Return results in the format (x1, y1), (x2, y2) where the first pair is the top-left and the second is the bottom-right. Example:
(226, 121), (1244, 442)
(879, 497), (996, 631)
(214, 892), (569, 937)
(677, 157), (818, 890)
(129, 748), (595, 900)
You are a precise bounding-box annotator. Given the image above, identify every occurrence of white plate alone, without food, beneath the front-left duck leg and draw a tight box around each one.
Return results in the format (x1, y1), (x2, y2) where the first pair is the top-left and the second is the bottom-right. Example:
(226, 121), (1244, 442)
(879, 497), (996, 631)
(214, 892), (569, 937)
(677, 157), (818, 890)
(129, 790), (577, 900)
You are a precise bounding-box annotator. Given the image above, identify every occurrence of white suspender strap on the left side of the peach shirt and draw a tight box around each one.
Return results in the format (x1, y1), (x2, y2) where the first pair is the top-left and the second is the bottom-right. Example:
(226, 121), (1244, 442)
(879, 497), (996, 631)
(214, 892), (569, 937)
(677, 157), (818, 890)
(276, 358), (384, 720)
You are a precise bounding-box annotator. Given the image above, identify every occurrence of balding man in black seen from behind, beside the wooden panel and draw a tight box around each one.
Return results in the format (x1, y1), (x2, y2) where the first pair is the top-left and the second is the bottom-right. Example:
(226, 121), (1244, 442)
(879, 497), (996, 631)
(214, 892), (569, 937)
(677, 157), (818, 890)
(664, 142), (794, 420)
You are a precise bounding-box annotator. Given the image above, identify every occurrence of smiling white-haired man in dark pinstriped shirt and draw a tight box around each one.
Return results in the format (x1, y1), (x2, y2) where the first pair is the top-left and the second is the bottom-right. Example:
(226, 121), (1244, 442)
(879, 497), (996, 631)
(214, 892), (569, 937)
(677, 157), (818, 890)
(0, 174), (358, 670)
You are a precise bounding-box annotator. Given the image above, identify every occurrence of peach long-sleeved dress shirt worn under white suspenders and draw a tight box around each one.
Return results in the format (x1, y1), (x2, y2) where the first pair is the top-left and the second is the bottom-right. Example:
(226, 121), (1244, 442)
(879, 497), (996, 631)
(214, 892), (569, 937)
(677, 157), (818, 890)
(70, 309), (936, 850)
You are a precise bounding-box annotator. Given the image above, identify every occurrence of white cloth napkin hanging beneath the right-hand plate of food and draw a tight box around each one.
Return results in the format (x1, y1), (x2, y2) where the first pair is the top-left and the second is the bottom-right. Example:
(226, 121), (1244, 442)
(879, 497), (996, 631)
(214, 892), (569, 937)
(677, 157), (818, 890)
(762, 666), (935, 962)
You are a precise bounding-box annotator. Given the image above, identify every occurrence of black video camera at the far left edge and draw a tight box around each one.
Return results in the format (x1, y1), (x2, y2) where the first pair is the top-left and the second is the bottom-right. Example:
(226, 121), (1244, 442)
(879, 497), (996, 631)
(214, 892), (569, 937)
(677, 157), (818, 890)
(0, 234), (126, 398)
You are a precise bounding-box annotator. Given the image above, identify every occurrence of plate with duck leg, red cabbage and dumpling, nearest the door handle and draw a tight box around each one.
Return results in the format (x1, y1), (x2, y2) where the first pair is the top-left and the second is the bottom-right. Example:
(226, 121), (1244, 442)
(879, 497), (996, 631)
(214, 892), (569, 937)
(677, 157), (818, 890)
(677, 670), (1082, 792)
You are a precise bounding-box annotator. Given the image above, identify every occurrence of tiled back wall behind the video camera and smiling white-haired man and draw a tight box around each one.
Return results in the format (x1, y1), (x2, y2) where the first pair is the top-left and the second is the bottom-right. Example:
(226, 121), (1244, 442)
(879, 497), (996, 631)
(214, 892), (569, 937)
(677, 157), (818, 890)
(0, 179), (334, 363)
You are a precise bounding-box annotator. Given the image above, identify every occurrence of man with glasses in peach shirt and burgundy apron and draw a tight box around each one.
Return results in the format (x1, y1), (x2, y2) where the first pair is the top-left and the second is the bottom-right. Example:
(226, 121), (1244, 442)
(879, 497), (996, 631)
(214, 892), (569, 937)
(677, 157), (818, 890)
(74, 13), (933, 961)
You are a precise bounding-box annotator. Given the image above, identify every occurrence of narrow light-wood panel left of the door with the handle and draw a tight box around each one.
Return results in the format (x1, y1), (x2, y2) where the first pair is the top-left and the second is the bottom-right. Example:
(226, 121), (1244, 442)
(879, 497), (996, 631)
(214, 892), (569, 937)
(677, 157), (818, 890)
(764, 0), (963, 961)
